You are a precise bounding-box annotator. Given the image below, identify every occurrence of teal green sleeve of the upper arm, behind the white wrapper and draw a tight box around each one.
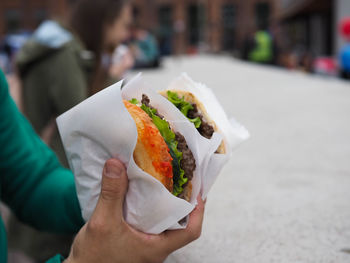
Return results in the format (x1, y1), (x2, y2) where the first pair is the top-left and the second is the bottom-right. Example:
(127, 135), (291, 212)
(0, 71), (83, 233)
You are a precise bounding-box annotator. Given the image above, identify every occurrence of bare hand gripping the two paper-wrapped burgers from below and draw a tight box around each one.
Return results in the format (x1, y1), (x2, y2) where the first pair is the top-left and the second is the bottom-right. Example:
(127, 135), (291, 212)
(66, 159), (204, 263)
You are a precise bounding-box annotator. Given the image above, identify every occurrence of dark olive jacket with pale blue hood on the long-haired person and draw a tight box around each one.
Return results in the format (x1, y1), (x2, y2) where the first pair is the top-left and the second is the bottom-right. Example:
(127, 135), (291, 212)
(16, 21), (95, 166)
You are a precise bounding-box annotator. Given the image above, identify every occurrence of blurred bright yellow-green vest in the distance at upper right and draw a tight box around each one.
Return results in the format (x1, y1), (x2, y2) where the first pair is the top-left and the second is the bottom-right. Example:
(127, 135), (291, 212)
(248, 31), (273, 63)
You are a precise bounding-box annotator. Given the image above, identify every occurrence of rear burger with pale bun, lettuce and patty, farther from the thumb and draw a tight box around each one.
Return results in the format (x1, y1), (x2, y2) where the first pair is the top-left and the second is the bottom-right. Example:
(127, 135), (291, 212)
(159, 90), (226, 154)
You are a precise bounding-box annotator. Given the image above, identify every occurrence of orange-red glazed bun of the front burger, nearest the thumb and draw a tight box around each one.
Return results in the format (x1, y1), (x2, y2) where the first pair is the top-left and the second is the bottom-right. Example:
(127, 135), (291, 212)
(123, 100), (173, 193)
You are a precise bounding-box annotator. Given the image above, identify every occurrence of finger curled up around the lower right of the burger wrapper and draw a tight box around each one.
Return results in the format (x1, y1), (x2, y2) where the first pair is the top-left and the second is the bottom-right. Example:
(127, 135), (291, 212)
(162, 196), (204, 252)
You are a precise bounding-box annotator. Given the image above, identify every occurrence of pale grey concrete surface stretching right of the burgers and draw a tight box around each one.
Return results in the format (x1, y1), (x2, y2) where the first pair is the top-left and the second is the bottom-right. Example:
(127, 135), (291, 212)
(131, 56), (350, 263)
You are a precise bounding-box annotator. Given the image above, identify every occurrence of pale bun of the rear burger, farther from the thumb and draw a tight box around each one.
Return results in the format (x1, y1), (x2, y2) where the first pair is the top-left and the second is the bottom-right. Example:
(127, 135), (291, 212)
(159, 90), (226, 154)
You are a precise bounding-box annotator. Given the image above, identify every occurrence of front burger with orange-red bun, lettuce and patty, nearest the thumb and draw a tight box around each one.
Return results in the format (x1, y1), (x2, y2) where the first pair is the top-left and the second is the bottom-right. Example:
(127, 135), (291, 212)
(123, 94), (196, 201)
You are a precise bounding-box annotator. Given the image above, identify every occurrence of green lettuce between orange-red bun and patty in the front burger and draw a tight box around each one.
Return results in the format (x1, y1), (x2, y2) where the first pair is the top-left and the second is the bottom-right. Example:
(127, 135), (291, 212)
(141, 104), (188, 196)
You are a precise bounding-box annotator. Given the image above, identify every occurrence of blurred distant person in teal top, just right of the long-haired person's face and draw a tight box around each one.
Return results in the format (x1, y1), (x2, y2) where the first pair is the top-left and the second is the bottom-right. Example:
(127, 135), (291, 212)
(131, 27), (160, 69)
